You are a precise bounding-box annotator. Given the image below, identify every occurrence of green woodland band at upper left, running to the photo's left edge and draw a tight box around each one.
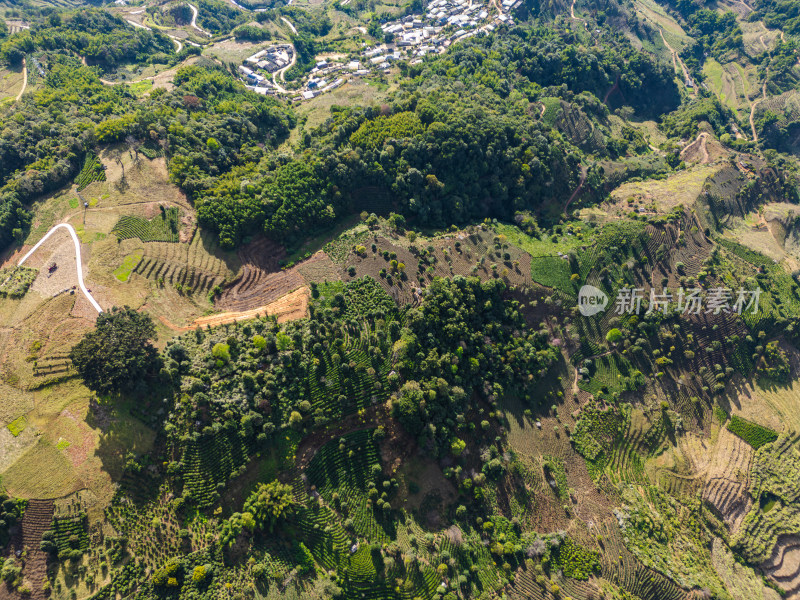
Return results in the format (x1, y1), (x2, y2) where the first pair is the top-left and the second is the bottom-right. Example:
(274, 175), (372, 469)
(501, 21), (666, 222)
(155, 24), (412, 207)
(0, 54), (294, 247)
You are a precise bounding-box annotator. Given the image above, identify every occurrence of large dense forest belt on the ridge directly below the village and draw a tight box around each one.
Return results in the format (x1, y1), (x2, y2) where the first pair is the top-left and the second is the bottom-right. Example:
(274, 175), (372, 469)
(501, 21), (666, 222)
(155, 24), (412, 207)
(192, 28), (679, 247)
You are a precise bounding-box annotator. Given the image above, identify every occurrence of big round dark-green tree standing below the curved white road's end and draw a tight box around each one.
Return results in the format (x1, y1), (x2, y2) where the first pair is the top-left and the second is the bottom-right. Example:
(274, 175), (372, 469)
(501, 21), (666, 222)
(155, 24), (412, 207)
(69, 306), (162, 395)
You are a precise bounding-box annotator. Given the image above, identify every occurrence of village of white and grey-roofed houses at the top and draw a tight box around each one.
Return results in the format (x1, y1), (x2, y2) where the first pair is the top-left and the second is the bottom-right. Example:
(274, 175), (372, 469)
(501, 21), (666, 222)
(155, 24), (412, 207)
(239, 0), (521, 102)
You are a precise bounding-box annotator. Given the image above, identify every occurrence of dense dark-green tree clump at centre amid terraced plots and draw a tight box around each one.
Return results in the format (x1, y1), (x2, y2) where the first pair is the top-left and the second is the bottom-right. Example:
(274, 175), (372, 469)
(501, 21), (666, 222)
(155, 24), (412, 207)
(393, 277), (557, 449)
